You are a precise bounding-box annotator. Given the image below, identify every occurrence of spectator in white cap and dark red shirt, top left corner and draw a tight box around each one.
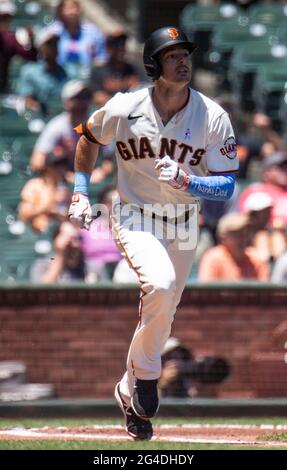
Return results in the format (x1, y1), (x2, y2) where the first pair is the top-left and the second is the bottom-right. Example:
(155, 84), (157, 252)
(0, 0), (37, 93)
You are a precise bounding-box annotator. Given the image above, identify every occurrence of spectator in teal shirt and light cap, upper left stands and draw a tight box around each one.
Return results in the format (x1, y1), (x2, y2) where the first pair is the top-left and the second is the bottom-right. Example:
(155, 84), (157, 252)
(17, 30), (68, 115)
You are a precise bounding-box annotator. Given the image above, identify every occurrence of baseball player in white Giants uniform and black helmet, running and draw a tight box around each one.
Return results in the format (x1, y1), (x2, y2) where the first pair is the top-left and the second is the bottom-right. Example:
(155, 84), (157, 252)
(69, 27), (238, 439)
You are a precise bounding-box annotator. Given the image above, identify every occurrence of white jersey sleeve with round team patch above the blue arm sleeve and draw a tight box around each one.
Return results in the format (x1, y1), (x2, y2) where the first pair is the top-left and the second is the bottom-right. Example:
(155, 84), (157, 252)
(206, 112), (239, 173)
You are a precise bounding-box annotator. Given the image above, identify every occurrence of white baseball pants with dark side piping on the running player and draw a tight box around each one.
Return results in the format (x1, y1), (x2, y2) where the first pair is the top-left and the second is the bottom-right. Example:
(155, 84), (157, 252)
(111, 203), (198, 399)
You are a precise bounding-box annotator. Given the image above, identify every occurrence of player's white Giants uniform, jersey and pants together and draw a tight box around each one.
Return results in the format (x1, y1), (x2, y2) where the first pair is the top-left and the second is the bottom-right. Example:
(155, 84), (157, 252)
(86, 87), (238, 397)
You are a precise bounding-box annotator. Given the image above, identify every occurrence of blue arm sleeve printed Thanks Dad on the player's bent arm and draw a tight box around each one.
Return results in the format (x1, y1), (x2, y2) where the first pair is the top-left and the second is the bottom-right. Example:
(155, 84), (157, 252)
(186, 173), (235, 201)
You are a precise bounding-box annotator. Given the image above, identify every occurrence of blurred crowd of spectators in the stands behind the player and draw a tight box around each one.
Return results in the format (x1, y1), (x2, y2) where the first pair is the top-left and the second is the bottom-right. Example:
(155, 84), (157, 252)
(0, 0), (287, 283)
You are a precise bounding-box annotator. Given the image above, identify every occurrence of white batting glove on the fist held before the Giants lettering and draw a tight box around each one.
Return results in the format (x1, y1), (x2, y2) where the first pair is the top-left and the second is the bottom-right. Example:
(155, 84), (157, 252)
(155, 155), (189, 190)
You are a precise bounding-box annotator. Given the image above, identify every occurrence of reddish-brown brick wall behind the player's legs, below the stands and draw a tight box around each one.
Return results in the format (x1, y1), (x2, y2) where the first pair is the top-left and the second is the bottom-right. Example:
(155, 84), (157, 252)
(0, 285), (287, 398)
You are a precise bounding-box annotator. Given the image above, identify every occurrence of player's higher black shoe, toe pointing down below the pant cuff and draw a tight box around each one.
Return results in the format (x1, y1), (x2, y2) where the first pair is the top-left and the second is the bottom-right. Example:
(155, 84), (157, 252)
(131, 379), (159, 419)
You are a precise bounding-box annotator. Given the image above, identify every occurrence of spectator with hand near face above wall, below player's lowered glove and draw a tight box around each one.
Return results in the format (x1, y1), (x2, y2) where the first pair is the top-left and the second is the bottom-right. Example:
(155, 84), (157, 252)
(30, 221), (86, 283)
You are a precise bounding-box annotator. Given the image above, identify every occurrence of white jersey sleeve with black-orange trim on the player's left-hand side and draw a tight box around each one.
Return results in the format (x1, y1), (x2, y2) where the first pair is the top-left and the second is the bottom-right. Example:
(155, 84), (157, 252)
(86, 93), (122, 145)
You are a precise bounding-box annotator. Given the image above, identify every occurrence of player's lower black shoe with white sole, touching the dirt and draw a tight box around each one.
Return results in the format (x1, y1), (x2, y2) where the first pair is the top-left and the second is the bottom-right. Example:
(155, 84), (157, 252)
(115, 382), (153, 441)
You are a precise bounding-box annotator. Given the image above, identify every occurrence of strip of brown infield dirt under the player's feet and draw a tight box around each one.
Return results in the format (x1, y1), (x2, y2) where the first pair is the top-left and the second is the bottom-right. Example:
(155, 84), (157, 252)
(0, 424), (287, 448)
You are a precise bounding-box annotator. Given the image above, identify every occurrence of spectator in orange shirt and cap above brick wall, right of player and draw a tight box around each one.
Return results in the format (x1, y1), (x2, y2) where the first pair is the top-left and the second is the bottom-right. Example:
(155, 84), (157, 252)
(198, 213), (268, 282)
